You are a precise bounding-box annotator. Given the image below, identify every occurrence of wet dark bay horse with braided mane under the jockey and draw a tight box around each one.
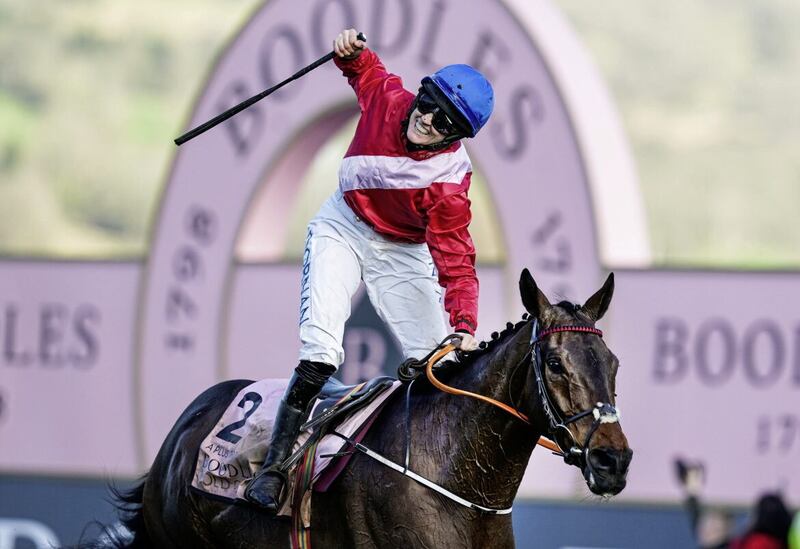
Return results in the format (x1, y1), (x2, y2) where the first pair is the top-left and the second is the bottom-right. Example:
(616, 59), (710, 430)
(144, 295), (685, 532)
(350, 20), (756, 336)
(101, 269), (633, 549)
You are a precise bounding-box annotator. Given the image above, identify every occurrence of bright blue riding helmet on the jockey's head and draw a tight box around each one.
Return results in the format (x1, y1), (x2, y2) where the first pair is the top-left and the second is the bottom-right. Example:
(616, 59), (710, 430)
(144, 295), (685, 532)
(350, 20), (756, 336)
(422, 65), (494, 137)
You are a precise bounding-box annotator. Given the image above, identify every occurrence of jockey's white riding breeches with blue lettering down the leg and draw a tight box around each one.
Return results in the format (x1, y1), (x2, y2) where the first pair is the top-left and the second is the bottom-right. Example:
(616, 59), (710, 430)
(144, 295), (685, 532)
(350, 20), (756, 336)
(300, 190), (448, 368)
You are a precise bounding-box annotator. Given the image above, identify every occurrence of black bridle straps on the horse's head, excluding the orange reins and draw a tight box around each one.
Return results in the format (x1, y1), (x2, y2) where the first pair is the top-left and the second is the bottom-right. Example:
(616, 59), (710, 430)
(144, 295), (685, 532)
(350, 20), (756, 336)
(526, 318), (620, 468)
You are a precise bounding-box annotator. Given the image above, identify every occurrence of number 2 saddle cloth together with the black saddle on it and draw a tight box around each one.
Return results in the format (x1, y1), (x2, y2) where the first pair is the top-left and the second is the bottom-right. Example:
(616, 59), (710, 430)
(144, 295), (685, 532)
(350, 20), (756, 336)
(192, 377), (400, 514)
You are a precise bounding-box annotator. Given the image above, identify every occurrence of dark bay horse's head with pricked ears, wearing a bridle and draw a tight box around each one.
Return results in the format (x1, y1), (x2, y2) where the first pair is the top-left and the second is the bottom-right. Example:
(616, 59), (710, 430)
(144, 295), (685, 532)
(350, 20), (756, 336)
(519, 269), (633, 496)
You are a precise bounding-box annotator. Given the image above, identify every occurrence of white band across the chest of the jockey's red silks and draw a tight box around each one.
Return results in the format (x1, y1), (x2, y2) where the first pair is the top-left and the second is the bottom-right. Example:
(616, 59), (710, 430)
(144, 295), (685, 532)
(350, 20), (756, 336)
(339, 146), (472, 191)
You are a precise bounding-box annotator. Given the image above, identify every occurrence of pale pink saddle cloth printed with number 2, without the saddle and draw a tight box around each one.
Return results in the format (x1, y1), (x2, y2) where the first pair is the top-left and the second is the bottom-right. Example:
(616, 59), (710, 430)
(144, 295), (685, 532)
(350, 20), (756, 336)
(192, 379), (400, 514)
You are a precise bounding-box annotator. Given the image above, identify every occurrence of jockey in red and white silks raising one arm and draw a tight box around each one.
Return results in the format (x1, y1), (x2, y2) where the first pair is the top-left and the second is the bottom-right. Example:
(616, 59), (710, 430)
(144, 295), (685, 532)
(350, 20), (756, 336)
(245, 29), (494, 513)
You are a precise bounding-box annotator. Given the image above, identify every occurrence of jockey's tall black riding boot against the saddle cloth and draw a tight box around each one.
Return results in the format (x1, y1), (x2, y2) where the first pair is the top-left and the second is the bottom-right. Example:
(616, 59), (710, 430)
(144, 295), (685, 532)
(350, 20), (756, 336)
(244, 360), (336, 514)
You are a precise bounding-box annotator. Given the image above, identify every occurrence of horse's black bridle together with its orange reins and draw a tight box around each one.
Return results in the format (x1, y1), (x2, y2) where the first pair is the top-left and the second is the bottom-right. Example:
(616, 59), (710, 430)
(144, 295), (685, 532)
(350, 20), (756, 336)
(426, 318), (620, 469)
